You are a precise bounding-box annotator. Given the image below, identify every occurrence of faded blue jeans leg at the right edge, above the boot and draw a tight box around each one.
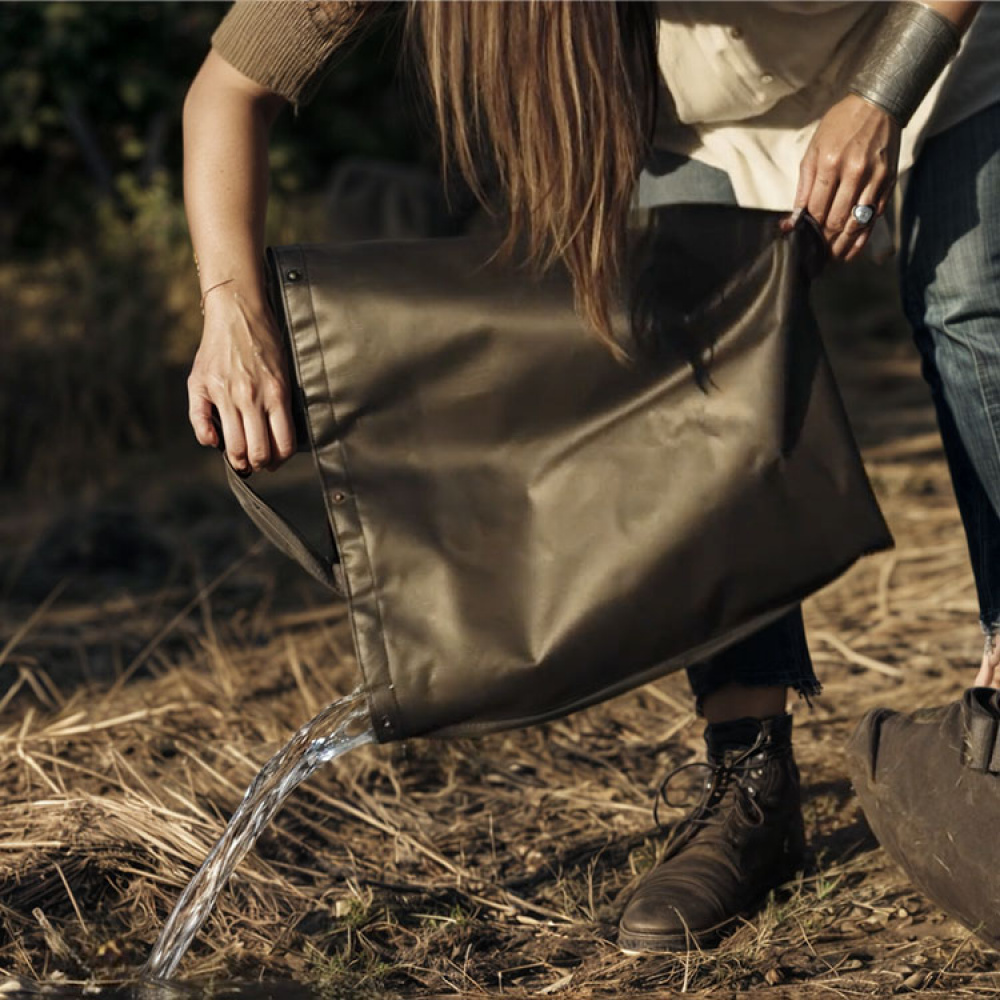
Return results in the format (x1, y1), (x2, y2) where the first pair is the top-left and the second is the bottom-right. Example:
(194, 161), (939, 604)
(899, 104), (1000, 641)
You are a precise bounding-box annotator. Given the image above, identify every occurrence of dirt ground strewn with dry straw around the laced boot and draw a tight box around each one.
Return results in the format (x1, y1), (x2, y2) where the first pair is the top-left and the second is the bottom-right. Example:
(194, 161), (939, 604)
(0, 258), (1000, 1000)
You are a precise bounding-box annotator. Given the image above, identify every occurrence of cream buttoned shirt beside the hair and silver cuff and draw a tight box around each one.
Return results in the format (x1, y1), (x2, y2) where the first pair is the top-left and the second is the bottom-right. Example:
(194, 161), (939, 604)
(656, 0), (1000, 211)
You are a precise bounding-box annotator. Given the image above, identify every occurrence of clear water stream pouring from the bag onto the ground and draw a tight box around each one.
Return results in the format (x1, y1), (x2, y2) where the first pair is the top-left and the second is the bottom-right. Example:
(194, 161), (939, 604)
(142, 690), (375, 980)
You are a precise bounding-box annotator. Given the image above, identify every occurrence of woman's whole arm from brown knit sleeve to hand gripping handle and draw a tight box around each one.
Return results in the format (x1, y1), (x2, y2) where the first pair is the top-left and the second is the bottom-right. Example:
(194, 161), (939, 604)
(184, 6), (381, 471)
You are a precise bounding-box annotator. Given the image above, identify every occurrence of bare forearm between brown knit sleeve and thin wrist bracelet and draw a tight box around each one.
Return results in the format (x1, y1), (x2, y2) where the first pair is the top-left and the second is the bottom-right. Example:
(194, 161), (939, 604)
(184, 53), (285, 306)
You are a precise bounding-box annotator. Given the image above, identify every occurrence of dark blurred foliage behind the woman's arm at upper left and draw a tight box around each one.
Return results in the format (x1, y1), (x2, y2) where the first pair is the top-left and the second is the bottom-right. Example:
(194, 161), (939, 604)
(0, 0), (422, 489)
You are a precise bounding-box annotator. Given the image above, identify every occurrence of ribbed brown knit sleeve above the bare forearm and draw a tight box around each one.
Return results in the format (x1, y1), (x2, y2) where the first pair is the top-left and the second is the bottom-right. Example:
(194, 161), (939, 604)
(212, 0), (383, 105)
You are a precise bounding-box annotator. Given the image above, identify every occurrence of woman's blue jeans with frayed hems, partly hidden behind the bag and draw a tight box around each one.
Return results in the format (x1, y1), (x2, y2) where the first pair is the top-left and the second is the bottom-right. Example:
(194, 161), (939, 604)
(638, 105), (1000, 705)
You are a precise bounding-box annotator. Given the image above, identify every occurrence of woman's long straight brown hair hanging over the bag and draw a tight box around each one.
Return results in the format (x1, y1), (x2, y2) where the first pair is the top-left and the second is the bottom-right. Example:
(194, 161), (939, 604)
(407, 0), (656, 358)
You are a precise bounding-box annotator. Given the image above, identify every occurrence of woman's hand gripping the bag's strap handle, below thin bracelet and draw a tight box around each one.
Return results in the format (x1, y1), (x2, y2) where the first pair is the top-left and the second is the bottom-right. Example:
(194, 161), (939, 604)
(188, 285), (295, 472)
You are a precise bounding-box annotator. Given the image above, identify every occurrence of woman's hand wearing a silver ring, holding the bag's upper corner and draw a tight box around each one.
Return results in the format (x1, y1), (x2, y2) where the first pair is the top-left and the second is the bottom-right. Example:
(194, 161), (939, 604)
(795, 94), (901, 260)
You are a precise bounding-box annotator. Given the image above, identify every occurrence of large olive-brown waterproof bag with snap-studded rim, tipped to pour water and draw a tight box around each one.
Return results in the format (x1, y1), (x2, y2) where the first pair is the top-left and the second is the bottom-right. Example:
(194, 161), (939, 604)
(229, 206), (891, 740)
